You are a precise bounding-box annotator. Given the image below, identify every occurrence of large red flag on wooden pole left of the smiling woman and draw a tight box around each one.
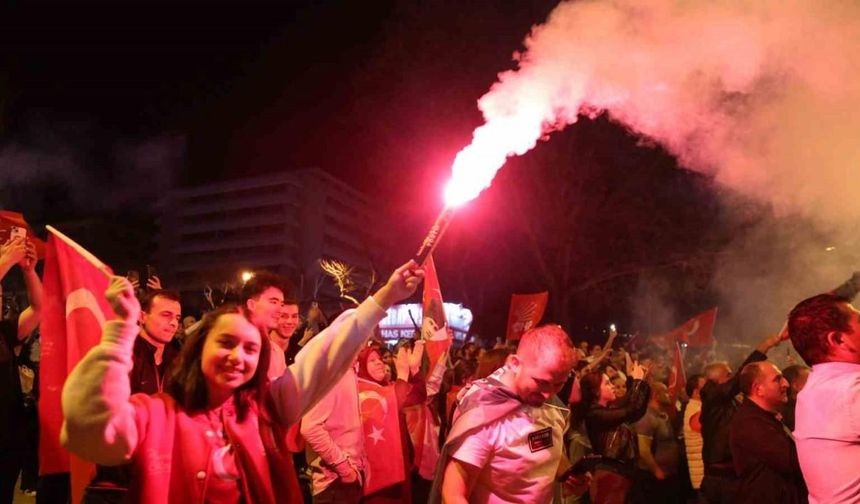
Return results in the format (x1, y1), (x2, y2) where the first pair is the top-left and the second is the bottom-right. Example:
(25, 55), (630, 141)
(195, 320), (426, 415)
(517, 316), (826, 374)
(39, 234), (114, 502)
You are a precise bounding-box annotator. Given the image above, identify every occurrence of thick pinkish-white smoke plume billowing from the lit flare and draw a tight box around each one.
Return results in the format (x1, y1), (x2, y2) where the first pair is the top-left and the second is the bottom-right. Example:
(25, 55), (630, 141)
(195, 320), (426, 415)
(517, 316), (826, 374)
(454, 0), (860, 344)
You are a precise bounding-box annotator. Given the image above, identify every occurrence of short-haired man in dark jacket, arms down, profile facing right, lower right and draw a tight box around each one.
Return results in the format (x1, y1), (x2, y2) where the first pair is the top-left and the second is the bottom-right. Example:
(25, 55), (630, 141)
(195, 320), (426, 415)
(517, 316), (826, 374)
(730, 362), (807, 504)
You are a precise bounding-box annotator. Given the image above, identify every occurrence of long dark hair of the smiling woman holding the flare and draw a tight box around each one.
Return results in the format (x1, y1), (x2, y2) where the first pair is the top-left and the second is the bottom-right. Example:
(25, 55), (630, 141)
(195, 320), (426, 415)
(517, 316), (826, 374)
(166, 304), (271, 422)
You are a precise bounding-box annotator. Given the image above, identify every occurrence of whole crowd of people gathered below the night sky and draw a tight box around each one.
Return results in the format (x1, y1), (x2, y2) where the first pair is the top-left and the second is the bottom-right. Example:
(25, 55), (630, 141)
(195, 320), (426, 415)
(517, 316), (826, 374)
(0, 233), (860, 504)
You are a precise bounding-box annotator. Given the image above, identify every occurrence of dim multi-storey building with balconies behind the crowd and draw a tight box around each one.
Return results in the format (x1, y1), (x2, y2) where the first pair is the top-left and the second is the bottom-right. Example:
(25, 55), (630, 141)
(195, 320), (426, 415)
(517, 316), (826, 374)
(159, 168), (387, 301)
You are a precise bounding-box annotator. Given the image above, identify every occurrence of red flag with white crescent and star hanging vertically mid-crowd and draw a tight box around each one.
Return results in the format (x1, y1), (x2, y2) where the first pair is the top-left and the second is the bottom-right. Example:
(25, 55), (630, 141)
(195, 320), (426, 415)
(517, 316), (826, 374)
(358, 378), (406, 495)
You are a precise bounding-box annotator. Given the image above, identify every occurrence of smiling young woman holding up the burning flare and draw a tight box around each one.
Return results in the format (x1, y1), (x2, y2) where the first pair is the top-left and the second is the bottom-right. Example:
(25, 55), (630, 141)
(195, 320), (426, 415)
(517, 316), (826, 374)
(61, 262), (423, 503)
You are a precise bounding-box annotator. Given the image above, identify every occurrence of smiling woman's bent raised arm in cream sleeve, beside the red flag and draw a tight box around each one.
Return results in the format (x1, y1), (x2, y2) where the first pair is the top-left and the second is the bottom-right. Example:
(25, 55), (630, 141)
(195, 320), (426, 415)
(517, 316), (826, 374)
(60, 277), (140, 465)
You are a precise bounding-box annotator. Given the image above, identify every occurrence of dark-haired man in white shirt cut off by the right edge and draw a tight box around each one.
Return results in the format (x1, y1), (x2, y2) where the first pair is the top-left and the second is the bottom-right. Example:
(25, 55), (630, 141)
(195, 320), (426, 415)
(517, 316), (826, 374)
(788, 294), (860, 504)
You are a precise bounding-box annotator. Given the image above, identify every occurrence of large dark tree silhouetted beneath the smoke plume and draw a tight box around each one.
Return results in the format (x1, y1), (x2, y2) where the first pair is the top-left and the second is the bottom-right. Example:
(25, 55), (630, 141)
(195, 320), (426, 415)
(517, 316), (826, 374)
(488, 117), (719, 330)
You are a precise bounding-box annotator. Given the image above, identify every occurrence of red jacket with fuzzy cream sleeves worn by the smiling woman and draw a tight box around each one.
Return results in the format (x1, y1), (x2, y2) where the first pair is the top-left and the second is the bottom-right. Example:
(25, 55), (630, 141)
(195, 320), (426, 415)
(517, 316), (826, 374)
(60, 298), (385, 504)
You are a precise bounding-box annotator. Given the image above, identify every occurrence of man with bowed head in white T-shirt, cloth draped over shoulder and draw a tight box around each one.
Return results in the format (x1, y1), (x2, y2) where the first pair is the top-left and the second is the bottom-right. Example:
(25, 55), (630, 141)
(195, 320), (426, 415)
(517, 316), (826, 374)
(431, 326), (576, 504)
